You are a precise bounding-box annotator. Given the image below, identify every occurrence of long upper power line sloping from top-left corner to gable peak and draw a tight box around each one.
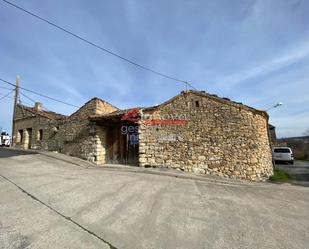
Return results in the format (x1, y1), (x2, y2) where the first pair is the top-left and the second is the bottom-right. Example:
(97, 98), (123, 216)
(2, 0), (197, 90)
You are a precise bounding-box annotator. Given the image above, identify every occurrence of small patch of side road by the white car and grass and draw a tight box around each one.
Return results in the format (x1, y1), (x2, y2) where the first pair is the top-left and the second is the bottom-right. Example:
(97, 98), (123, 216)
(275, 160), (309, 187)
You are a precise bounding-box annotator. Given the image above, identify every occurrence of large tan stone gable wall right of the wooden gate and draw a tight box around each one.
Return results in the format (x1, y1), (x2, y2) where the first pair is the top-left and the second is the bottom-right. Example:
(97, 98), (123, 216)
(139, 92), (273, 180)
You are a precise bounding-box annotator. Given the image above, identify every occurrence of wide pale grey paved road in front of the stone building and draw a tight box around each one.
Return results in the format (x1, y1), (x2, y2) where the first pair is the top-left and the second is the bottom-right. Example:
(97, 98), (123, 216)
(0, 149), (309, 249)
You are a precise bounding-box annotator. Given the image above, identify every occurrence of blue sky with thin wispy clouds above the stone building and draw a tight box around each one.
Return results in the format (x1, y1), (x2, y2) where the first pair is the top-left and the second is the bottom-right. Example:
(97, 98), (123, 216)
(0, 0), (309, 137)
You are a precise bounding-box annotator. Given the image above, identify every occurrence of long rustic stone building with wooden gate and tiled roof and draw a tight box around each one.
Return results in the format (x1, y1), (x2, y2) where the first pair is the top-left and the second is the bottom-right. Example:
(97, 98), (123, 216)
(13, 90), (273, 180)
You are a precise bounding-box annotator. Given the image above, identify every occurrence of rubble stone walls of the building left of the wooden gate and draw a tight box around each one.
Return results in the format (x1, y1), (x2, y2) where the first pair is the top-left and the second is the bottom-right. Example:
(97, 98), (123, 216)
(13, 98), (117, 164)
